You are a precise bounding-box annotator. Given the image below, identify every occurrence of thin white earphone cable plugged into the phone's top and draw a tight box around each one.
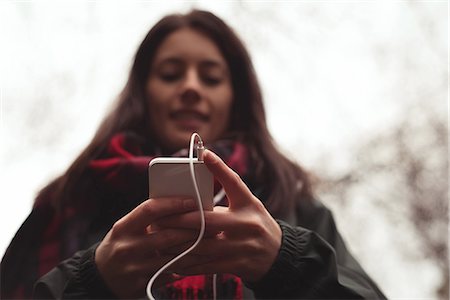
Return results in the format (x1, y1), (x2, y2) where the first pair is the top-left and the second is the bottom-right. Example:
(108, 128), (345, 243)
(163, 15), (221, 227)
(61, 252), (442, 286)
(146, 132), (219, 300)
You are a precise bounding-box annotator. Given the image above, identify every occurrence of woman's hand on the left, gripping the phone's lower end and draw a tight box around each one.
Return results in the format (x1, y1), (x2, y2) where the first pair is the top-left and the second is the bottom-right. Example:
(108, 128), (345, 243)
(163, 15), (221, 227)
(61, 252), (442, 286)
(95, 198), (198, 299)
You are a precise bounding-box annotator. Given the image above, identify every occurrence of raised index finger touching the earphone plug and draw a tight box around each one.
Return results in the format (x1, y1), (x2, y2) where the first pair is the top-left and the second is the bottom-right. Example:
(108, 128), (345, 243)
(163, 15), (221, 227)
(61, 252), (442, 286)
(203, 150), (253, 209)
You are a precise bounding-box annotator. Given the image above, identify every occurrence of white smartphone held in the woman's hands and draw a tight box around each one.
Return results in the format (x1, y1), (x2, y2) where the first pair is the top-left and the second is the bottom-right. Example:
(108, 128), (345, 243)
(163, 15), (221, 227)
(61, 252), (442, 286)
(148, 157), (214, 210)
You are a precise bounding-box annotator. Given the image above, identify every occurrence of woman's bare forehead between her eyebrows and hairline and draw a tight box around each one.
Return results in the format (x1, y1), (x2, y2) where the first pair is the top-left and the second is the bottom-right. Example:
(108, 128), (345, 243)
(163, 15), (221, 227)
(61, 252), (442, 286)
(154, 28), (226, 65)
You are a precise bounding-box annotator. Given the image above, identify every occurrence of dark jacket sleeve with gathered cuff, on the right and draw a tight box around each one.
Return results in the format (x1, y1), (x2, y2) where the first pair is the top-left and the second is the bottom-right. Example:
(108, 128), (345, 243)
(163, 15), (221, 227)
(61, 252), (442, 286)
(247, 201), (385, 299)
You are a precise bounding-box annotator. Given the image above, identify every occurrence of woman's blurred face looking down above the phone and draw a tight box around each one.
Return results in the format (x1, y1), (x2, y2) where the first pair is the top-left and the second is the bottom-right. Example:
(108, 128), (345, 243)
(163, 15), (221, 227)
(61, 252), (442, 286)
(146, 28), (233, 151)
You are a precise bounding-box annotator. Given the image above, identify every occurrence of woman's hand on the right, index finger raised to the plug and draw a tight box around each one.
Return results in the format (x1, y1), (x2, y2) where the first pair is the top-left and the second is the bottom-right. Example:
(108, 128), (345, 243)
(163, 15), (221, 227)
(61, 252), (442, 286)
(158, 150), (282, 282)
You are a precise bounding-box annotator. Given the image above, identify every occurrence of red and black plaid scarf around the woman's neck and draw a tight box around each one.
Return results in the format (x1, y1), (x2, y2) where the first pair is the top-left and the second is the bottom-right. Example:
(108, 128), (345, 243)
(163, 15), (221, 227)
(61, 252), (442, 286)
(1, 133), (249, 299)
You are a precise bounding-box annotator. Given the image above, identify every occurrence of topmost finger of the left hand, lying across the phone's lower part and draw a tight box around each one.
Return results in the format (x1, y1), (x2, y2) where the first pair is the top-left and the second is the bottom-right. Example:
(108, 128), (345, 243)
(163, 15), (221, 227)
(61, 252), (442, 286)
(112, 197), (196, 234)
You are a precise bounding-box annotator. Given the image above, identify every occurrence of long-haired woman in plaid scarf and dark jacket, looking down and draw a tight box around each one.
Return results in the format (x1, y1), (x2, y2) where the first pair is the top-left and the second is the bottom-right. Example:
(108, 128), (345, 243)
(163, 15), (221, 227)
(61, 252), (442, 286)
(1, 10), (384, 299)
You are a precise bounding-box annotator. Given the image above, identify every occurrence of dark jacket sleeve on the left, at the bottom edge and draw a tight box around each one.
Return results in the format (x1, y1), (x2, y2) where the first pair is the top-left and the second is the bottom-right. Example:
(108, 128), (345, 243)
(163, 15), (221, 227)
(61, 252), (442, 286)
(33, 244), (116, 299)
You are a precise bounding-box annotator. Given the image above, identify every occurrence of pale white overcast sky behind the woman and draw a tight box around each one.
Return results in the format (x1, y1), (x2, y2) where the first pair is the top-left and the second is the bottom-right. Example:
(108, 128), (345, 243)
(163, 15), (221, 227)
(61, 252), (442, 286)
(0, 1), (448, 298)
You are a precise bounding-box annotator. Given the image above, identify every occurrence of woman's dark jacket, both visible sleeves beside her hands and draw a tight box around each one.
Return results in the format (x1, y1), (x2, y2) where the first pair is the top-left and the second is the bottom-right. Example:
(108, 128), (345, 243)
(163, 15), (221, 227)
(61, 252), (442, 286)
(35, 200), (385, 299)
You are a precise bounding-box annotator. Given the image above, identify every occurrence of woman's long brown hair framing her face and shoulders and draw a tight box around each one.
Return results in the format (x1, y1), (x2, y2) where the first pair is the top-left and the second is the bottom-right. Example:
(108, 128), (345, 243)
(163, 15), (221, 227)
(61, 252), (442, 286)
(41, 10), (311, 216)
